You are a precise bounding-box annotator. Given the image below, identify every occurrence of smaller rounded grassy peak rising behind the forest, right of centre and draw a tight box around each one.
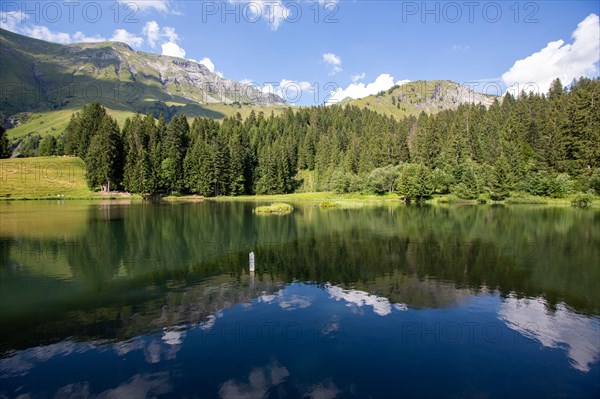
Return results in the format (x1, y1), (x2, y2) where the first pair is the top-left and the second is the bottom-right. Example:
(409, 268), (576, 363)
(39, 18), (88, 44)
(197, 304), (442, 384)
(341, 80), (498, 118)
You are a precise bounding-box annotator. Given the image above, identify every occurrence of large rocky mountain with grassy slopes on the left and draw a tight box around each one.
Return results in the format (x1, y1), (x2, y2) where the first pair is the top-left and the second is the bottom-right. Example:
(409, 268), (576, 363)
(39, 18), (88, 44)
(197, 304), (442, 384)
(0, 29), (285, 129)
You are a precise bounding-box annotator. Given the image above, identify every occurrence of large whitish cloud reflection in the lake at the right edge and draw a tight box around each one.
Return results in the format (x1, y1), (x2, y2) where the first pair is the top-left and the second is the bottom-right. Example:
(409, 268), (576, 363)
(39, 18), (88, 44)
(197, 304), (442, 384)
(498, 297), (600, 372)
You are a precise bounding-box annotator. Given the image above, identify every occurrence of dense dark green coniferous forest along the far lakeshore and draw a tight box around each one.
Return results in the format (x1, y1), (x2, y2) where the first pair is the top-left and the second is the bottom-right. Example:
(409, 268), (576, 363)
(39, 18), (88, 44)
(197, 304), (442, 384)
(21, 78), (600, 200)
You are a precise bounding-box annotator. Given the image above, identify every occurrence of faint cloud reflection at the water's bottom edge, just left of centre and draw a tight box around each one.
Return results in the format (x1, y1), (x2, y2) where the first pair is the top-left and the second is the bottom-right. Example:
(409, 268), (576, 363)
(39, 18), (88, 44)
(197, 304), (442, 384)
(219, 360), (290, 399)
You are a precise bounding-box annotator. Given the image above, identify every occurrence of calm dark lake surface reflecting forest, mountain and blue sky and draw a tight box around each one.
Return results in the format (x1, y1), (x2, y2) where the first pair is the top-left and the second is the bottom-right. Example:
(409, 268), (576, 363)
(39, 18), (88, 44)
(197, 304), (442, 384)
(0, 202), (600, 398)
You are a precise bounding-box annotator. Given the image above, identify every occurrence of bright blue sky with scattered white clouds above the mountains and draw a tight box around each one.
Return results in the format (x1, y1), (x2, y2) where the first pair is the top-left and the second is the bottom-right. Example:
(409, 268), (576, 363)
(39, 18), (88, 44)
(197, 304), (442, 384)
(0, 0), (600, 105)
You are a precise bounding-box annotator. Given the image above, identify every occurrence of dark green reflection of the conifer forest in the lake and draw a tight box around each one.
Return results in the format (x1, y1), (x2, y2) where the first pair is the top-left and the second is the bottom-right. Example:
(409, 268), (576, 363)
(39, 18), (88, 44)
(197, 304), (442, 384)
(0, 203), (600, 352)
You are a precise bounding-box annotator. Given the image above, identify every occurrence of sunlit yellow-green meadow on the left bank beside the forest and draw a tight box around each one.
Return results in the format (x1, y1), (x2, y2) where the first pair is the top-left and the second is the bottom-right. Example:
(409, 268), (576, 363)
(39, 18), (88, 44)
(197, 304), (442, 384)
(0, 157), (100, 199)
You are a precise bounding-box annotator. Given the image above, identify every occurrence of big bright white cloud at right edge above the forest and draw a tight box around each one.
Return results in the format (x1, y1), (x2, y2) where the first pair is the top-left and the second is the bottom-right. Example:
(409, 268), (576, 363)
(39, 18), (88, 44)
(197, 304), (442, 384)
(502, 14), (600, 94)
